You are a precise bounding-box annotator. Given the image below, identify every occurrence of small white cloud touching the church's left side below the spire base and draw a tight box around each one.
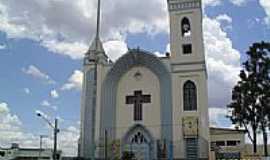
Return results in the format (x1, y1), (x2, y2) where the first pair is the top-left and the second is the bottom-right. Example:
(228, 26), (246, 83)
(61, 70), (83, 90)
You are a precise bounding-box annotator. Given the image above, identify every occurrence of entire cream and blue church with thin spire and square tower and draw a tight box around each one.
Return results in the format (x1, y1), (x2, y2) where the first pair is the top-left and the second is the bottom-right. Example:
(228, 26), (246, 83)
(79, 0), (210, 160)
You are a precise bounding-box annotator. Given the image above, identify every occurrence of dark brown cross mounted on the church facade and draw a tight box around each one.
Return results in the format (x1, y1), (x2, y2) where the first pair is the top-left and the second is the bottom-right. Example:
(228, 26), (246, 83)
(126, 91), (151, 121)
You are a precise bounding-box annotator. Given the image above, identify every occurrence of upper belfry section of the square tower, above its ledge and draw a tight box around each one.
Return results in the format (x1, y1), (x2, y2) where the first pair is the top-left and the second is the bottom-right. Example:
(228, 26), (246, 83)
(168, 0), (205, 63)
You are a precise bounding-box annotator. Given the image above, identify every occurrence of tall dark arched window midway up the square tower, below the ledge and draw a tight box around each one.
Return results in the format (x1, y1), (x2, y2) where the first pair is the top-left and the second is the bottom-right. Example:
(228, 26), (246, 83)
(183, 81), (197, 111)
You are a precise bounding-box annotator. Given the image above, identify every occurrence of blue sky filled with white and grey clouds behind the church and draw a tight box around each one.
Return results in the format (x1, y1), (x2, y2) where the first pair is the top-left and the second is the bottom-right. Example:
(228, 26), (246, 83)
(0, 0), (270, 155)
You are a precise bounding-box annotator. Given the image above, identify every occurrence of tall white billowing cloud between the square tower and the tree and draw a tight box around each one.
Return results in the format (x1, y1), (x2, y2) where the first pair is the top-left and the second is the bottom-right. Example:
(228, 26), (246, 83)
(203, 16), (240, 107)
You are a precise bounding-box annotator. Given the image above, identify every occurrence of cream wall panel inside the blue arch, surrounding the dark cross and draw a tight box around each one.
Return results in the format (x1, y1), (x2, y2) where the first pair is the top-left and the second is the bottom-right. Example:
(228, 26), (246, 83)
(116, 67), (161, 139)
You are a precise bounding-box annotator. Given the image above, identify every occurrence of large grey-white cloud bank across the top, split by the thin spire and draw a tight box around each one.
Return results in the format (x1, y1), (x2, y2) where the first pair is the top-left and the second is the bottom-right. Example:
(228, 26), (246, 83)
(0, 0), (169, 59)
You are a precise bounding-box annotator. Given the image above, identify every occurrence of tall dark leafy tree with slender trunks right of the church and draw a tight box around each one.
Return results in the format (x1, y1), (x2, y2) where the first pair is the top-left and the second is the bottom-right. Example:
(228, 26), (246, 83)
(227, 42), (270, 155)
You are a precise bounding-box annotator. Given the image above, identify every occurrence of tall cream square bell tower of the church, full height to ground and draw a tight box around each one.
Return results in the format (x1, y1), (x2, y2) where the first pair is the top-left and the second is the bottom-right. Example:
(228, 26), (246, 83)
(167, 0), (210, 159)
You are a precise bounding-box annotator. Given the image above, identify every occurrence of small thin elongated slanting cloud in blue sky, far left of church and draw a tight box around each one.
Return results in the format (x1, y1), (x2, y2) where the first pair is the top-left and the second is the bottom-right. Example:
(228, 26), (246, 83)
(22, 65), (55, 84)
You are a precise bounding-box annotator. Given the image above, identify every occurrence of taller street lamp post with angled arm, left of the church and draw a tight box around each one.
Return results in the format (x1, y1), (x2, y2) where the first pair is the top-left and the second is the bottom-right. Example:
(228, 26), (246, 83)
(37, 113), (60, 160)
